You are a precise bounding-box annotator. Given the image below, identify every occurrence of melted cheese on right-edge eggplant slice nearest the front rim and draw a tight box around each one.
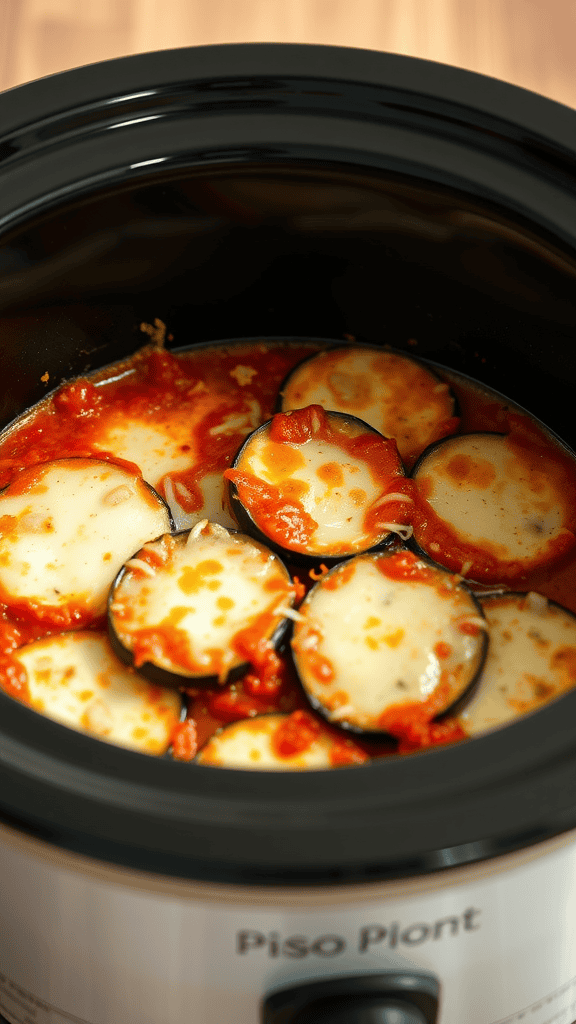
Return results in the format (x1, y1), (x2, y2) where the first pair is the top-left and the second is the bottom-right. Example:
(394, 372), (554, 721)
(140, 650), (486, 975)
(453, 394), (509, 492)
(460, 594), (576, 735)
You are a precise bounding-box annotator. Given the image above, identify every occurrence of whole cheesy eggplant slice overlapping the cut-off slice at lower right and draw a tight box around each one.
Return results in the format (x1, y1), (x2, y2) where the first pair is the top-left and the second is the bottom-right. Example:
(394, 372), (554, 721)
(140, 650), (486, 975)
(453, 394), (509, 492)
(291, 547), (489, 739)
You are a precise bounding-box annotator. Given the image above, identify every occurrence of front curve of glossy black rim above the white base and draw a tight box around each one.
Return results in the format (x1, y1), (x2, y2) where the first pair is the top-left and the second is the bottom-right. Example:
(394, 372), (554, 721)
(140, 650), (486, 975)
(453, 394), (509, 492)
(0, 638), (576, 885)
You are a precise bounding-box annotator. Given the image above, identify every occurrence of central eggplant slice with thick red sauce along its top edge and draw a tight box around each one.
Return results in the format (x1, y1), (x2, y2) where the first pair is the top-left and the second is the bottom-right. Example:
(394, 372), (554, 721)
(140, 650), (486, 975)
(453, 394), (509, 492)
(224, 406), (412, 564)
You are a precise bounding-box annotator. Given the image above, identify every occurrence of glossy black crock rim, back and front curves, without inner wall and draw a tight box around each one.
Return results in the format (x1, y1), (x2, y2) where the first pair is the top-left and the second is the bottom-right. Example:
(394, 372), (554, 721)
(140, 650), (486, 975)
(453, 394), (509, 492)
(0, 44), (576, 884)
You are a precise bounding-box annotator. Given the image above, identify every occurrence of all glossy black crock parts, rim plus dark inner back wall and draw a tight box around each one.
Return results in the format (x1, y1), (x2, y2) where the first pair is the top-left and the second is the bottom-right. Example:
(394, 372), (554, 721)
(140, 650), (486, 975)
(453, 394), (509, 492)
(0, 45), (576, 885)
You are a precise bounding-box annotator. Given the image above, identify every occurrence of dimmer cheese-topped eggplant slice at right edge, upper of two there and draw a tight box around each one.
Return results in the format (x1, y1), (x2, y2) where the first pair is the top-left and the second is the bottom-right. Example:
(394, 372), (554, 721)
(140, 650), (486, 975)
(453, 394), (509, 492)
(412, 433), (575, 584)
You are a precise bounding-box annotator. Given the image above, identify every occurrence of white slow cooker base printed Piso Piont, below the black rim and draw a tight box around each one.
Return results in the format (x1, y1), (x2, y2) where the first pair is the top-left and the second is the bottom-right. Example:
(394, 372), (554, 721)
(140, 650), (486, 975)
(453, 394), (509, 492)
(0, 826), (576, 1024)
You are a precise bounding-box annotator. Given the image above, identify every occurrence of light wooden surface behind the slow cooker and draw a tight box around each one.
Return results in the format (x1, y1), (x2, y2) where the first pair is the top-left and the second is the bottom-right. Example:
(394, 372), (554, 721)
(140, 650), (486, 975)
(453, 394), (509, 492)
(0, 0), (576, 108)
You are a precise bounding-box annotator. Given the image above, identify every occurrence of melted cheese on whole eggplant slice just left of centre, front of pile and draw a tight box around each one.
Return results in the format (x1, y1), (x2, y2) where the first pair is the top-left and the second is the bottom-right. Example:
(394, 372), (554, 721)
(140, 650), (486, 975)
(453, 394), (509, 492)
(111, 524), (294, 678)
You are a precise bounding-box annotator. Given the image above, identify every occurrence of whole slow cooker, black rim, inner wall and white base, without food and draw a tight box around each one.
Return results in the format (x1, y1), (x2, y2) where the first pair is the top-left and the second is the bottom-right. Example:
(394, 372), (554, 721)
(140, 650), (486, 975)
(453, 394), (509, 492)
(0, 44), (576, 1024)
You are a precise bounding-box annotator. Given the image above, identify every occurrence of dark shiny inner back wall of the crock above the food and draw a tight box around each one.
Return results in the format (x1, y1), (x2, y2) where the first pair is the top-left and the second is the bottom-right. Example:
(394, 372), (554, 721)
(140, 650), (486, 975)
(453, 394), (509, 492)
(0, 167), (576, 439)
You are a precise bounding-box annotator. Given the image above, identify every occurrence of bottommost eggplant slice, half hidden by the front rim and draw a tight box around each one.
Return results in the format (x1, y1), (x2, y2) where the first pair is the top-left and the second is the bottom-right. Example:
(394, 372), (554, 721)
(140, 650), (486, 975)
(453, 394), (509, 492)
(196, 711), (368, 771)
